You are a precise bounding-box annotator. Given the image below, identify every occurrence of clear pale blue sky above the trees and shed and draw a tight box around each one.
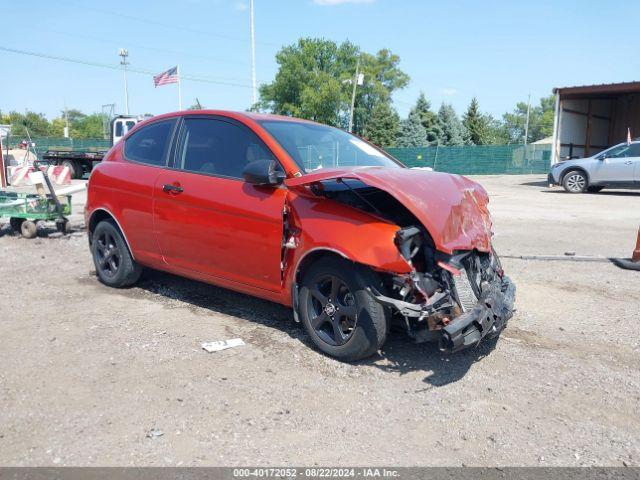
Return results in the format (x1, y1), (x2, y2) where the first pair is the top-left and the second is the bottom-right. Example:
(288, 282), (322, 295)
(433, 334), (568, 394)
(0, 0), (640, 118)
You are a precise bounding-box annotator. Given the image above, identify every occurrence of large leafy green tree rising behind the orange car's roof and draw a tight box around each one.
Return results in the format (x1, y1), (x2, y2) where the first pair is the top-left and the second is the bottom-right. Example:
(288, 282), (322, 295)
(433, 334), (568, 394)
(258, 38), (409, 134)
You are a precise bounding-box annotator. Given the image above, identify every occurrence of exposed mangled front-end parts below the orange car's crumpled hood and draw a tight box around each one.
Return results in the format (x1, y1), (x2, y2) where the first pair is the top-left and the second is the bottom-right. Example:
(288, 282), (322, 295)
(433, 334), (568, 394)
(370, 226), (515, 352)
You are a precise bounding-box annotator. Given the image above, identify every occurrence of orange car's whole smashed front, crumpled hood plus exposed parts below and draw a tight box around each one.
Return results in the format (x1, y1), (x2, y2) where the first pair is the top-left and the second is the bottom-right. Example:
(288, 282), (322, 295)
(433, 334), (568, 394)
(288, 167), (515, 352)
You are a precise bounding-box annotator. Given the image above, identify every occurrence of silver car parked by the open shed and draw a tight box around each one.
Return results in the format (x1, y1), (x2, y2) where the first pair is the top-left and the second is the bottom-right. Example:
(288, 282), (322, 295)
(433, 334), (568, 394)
(548, 140), (640, 193)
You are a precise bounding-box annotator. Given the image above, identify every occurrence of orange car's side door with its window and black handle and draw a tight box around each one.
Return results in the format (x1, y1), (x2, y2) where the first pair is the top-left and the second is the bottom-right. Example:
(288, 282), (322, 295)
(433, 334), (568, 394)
(154, 116), (286, 291)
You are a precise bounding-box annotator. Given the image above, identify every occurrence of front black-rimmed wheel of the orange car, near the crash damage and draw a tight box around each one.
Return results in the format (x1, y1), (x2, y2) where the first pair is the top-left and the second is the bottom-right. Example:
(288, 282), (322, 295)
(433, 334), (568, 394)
(298, 257), (389, 362)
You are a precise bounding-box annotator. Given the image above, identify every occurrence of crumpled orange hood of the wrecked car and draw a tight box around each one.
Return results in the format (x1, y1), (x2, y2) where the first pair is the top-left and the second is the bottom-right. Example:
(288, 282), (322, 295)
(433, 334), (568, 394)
(285, 167), (492, 253)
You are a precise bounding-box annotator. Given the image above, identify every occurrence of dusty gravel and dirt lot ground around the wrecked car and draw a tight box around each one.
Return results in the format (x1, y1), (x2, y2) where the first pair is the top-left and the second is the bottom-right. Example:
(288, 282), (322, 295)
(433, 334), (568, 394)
(0, 176), (640, 466)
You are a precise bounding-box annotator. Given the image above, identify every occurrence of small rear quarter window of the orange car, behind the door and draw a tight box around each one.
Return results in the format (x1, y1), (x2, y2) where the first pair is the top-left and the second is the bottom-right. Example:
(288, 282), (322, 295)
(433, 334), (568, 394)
(124, 119), (175, 167)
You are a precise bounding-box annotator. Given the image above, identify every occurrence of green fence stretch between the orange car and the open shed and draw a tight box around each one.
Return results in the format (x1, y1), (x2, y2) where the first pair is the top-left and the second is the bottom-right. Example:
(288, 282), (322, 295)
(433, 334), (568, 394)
(385, 145), (551, 175)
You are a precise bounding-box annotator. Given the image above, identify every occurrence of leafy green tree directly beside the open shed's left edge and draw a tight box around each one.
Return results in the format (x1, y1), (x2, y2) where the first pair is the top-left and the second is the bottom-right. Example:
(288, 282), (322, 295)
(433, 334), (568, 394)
(502, 95), (555, 143)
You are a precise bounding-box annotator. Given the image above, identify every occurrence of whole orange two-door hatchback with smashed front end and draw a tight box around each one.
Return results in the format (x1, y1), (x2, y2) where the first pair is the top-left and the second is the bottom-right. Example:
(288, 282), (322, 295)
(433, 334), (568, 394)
(86, 110), (515, 361)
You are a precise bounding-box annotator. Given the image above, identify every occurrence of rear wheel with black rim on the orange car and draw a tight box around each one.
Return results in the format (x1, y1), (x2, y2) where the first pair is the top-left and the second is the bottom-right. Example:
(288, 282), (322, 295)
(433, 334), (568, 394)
(91, 220), (142, 288)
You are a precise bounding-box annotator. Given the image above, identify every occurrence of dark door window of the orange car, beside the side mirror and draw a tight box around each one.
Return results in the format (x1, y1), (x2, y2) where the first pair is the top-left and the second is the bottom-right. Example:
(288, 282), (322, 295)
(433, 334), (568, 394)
(176, 118), (274, 178)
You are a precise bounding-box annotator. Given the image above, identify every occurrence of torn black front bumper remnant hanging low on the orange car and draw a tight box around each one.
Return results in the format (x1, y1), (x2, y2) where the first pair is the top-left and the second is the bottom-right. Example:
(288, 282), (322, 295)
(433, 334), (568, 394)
(439, 277), (516, 352)
